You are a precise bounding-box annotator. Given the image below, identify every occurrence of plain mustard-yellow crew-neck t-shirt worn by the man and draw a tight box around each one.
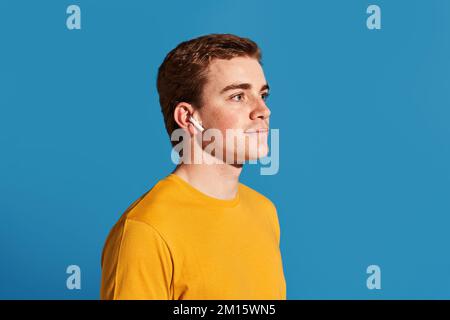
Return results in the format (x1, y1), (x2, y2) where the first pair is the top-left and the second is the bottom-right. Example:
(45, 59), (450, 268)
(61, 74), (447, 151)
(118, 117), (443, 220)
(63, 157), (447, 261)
(100, 174), (286, 300)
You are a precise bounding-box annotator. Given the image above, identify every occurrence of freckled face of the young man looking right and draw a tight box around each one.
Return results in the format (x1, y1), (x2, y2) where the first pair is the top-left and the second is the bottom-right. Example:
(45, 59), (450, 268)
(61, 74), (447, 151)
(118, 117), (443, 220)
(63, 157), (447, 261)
(198, 57), (270, 160)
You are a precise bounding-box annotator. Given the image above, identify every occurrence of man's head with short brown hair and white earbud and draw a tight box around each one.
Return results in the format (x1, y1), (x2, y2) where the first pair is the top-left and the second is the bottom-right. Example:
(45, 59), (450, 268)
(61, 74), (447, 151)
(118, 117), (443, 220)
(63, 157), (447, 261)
(157, 34), (270, 159)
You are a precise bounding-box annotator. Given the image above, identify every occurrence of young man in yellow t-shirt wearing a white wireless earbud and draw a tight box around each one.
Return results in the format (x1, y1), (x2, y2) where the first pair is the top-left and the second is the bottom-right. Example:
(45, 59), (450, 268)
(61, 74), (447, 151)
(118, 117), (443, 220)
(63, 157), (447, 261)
(101, 34), (286, 299)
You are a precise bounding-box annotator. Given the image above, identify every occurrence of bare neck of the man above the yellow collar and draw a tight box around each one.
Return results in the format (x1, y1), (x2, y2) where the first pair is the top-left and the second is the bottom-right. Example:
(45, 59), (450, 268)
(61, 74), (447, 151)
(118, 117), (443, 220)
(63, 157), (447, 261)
(172, 164), (242, 200)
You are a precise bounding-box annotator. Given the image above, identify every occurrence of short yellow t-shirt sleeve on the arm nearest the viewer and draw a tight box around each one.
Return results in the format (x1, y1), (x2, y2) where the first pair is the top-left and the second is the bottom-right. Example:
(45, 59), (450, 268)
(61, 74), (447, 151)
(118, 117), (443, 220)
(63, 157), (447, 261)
(113, 219), (173, 300)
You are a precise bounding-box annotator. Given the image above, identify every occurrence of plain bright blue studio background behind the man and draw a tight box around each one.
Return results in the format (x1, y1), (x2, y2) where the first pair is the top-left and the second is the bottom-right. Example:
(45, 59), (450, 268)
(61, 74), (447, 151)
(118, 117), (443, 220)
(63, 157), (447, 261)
(0, 0), (450, 299)
